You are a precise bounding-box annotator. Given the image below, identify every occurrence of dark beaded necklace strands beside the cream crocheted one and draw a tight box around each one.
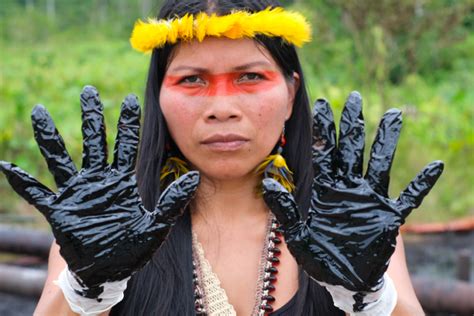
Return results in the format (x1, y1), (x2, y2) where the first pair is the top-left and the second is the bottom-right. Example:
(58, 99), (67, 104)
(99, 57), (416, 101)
(193, 214), (282, 316)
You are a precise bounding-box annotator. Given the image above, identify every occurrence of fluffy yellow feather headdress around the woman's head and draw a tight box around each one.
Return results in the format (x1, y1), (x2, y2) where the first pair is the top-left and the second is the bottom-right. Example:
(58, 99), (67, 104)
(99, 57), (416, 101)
(130, 7), (311, 53)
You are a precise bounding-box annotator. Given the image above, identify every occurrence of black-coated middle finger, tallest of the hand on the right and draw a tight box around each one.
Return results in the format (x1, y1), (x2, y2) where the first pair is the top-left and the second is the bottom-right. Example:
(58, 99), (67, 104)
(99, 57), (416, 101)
(337, 91), (365, 180)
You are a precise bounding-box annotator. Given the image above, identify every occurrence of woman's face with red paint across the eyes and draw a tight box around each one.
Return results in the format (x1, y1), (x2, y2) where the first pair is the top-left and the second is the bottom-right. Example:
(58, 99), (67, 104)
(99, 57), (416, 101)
(160, 38), (299, 180)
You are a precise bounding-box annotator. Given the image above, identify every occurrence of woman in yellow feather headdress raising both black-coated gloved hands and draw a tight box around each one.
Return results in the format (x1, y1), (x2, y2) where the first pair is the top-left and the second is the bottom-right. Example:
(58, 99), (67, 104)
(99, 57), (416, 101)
(1, 0), (442, 315)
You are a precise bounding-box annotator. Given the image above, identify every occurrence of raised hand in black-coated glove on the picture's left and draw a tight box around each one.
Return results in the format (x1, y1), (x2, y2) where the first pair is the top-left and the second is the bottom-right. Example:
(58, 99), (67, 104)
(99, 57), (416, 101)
(0, 86), (199, 298)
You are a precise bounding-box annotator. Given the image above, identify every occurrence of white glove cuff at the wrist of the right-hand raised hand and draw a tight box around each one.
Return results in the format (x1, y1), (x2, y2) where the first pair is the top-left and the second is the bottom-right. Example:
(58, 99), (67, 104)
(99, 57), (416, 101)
(319, 273), (398, 316)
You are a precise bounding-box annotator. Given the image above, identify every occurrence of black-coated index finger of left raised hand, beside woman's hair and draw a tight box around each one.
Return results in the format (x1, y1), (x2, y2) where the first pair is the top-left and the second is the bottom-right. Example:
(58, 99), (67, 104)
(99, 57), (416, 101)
(112, 94), (140, 171)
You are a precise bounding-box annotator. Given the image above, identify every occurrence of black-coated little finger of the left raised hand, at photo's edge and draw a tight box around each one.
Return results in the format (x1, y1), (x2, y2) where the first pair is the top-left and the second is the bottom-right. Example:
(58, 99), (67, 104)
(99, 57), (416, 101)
(0, 161), (54, 215)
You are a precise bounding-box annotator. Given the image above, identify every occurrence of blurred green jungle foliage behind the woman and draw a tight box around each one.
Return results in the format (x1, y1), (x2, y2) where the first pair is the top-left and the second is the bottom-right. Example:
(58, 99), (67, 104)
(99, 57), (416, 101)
(0, 0), (474, 314)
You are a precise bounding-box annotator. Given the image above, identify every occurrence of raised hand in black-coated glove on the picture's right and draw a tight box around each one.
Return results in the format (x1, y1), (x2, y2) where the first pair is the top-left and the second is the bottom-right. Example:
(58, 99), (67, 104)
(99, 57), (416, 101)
(263, 92), (443, 292)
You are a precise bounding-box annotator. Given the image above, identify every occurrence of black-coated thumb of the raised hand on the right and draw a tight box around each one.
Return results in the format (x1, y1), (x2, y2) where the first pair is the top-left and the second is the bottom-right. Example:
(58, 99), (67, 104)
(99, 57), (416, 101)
(262, 178), (300, 229)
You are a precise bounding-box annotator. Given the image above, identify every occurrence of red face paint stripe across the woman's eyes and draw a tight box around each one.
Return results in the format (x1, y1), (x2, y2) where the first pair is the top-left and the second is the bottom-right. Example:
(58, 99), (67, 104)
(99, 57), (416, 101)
(163, 71), (282, 96)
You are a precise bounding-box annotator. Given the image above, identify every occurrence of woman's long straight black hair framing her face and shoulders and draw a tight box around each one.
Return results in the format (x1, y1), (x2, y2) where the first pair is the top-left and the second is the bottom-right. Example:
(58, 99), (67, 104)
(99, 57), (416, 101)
(112, 0), (340, 315)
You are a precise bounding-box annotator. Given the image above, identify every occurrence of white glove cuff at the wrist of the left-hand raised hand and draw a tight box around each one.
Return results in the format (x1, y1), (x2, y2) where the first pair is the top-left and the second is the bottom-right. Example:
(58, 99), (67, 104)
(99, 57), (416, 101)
(54, 267), (130, 316)
